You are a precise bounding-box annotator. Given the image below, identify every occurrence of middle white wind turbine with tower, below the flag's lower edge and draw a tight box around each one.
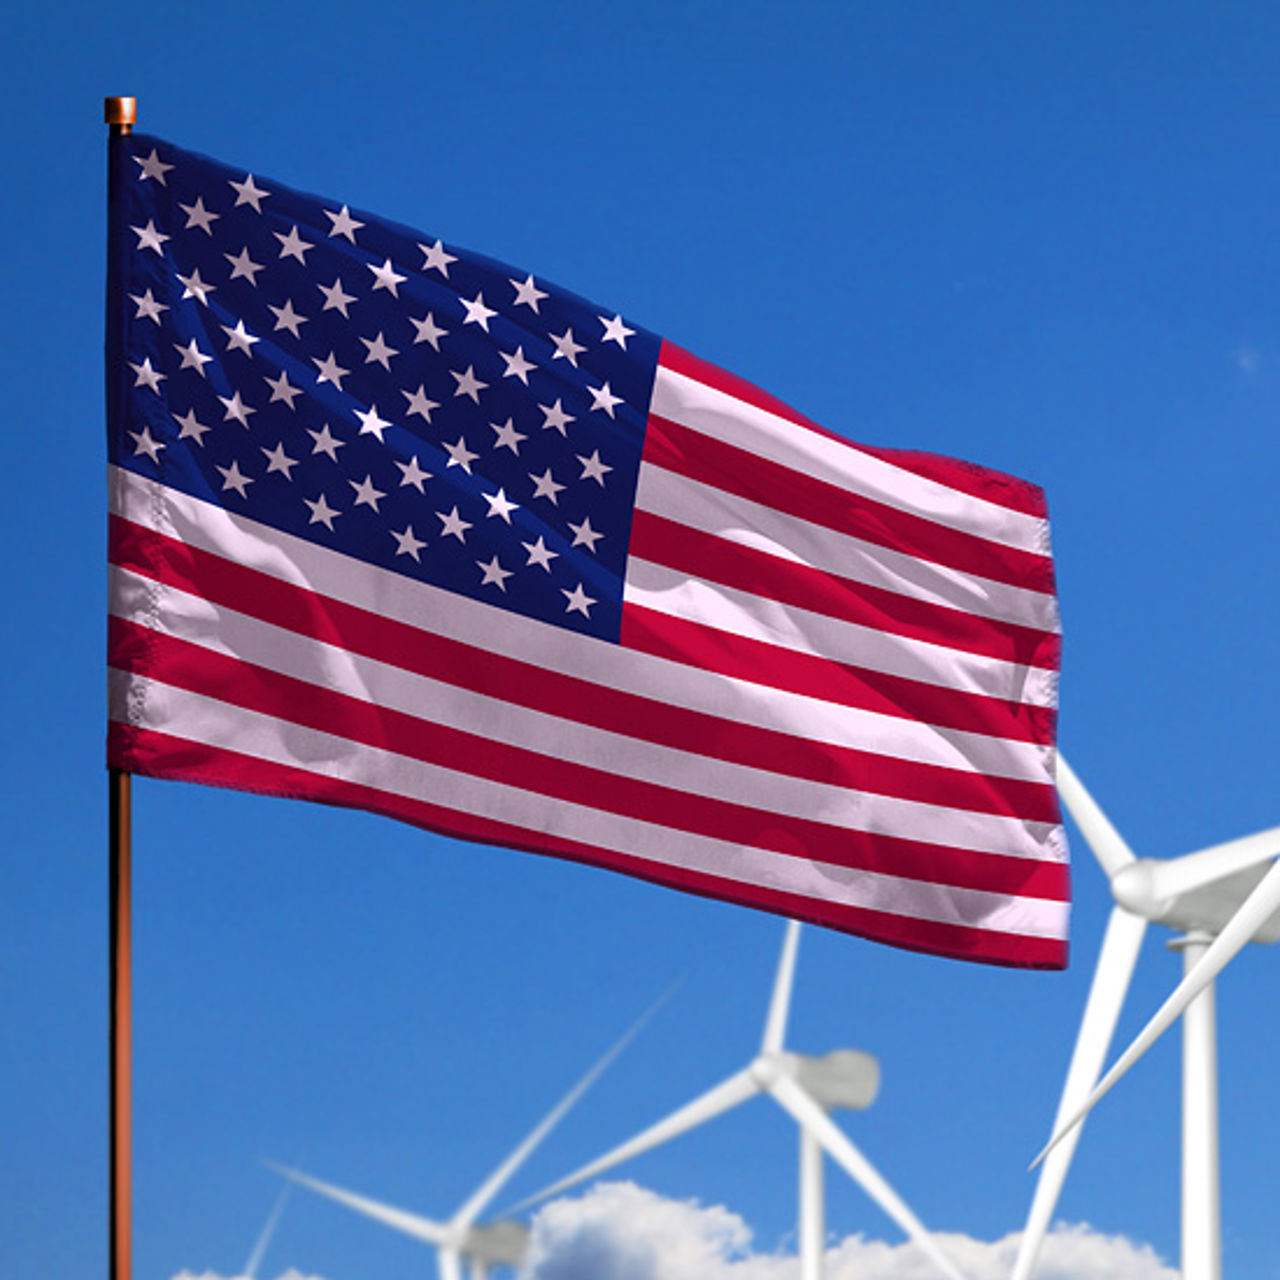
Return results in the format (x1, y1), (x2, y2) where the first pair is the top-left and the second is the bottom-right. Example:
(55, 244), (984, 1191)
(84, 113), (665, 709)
(516, 920), (963, 1280)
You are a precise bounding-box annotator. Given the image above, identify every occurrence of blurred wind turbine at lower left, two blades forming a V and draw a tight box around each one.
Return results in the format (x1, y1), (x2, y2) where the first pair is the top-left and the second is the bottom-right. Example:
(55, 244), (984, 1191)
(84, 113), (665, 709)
(270, 987), (675, 1280)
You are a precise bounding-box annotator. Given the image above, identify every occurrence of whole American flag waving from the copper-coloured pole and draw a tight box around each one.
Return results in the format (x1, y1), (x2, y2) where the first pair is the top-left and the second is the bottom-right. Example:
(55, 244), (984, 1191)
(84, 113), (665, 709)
(108, 134), (1069, 968)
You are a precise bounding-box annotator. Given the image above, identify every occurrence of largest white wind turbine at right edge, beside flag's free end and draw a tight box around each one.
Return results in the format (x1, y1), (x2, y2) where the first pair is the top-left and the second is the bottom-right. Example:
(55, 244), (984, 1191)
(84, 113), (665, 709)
(1012, 755), (1280, 1280)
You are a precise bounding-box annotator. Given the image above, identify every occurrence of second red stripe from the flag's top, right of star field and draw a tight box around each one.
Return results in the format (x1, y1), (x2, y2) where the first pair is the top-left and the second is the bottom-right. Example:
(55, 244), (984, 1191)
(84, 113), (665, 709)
(644, 413), (1053, 593)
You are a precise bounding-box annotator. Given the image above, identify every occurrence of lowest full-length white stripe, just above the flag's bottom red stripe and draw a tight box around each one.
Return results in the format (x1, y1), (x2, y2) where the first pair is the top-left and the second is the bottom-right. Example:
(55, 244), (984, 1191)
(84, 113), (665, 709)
(111, 672), (1068, 938)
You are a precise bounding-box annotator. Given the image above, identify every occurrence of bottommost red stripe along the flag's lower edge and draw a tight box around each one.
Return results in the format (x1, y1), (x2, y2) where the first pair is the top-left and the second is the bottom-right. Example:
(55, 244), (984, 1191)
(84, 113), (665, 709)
(108, 723), (1068, 969)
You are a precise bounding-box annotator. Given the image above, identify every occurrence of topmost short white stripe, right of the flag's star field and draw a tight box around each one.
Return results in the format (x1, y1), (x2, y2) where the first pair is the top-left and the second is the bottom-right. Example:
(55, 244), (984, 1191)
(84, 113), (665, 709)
(649, 365), (1048, 556)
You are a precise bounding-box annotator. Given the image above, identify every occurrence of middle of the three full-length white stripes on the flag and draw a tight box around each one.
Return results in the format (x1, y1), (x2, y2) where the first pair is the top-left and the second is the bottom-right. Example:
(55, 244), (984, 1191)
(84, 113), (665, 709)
(111, 568), (1066, 861)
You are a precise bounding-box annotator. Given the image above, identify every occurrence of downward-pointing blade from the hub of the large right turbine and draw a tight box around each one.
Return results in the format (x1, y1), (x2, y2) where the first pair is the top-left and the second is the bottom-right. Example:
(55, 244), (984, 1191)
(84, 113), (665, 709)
(1011, 906), (1147, 1280)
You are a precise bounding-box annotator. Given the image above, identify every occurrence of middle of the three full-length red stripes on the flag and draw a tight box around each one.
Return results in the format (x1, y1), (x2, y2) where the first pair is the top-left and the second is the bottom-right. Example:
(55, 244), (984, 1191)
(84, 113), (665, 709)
(108, 617), (1070, 901)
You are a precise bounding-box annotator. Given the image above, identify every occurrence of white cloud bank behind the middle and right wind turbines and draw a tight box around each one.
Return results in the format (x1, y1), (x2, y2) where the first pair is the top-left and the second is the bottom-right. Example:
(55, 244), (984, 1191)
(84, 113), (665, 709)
(521, 1183), (1178, 1280)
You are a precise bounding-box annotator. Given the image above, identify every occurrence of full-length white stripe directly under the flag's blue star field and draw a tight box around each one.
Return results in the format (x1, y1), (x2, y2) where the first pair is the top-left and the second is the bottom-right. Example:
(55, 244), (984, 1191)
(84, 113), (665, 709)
(110, 467), (1053, 785)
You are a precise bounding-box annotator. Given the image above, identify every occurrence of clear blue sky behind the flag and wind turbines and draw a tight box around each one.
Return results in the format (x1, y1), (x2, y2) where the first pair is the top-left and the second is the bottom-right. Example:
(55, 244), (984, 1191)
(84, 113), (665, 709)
(0, 0), (1280, 1280)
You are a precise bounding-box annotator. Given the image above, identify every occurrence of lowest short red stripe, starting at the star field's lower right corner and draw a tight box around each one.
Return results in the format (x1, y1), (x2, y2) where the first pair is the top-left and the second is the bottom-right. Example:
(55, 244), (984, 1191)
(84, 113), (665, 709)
(621, 602), (1057, 746)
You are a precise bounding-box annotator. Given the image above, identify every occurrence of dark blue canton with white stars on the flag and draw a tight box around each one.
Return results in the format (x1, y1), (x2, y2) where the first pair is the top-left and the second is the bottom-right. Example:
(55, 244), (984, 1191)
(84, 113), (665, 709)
(109, 134), (660, 640)
